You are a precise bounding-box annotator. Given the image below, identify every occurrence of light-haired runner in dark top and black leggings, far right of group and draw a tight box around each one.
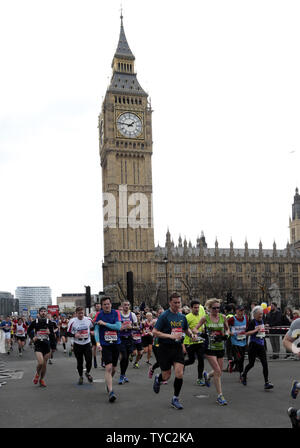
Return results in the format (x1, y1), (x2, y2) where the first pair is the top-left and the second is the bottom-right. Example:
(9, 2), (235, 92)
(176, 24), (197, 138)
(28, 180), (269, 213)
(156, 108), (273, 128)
(241, 306), (274, 390)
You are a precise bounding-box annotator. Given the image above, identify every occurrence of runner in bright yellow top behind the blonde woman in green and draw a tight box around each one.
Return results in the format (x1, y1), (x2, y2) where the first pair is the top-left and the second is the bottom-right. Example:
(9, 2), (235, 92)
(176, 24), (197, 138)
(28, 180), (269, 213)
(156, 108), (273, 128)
(183, 300), (205, 386)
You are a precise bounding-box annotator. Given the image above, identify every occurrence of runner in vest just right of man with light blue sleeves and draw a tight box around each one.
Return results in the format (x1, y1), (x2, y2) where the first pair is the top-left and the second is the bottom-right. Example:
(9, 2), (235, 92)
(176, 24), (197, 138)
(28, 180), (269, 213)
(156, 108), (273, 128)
(119, 300), (137, 384)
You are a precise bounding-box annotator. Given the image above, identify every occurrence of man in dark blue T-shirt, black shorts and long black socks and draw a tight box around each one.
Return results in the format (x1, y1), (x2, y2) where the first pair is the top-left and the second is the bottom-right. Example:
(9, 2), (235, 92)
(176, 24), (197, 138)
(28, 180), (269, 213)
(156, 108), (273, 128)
(153, 293), (196, 410)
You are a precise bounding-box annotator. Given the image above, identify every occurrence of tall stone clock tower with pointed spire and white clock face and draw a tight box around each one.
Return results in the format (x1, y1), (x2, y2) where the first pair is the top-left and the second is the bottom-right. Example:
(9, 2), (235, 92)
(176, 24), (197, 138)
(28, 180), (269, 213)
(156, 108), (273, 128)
(99, 16), (154, 299)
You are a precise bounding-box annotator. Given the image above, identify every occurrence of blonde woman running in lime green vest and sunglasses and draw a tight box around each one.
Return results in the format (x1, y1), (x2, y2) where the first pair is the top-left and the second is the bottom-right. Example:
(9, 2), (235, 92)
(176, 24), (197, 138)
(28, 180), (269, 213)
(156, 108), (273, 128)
(193, 298), (228, 406)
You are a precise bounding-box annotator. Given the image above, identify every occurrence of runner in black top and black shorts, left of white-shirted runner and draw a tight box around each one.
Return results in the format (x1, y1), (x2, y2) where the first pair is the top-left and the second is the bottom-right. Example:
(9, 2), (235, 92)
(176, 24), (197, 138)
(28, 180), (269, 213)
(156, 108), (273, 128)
(27, 307), (55, 387)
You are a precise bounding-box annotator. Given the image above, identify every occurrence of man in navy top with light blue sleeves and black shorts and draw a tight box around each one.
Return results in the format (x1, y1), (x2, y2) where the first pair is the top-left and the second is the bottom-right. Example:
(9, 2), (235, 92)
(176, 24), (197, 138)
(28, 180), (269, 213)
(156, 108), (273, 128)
(94, 297), (121, 403)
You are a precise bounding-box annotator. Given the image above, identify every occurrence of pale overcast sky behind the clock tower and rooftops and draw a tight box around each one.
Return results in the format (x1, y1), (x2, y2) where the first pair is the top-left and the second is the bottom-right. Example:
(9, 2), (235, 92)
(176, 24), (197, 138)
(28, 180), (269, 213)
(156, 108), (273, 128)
(0, 0), (300, 303)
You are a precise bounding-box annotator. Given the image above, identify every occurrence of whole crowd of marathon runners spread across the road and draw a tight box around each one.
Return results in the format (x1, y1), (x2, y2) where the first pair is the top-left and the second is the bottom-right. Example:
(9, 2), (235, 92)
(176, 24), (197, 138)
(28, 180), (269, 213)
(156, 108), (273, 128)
(1, 293), (300, 425)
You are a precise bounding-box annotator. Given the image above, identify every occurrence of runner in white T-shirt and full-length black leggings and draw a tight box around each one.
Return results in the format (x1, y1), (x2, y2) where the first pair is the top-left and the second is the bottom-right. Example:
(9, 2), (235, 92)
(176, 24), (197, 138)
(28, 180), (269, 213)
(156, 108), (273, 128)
(67, 306), (94, 385)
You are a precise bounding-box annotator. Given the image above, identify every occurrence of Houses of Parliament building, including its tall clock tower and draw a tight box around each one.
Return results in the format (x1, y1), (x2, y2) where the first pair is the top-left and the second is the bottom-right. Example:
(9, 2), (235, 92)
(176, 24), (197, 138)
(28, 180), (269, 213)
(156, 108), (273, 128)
(98, 16), (300, 305)
